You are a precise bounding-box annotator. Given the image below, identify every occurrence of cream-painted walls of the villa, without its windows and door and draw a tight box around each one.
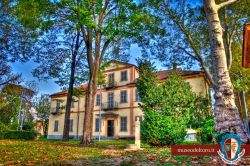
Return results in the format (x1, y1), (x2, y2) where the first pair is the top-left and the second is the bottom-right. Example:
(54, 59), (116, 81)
(48, 63), (209, 139)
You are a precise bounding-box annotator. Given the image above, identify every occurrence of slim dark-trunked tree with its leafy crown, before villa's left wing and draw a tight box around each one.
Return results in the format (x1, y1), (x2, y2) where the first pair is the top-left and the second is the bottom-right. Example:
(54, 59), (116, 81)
(33, 25), (88, 141)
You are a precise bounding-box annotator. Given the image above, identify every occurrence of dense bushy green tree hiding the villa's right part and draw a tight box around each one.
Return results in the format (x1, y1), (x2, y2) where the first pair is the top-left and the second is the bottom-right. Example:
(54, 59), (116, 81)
(136, 61), (208, 145)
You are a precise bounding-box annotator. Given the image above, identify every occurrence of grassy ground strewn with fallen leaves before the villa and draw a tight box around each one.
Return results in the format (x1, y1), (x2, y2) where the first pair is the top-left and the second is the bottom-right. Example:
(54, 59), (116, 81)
(0, 140), (249, 166)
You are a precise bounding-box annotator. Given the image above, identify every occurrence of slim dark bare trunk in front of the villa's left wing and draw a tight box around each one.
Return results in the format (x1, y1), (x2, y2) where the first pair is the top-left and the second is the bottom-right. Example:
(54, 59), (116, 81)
(63, 31), (80, 141)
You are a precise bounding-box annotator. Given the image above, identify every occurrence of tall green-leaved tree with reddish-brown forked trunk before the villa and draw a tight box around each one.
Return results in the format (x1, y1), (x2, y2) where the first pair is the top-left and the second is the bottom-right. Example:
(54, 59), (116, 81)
(71, 0), (154, 144)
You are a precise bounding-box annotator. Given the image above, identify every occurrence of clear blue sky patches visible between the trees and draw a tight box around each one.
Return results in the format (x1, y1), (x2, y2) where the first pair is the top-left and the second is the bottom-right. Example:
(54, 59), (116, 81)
(10, 45), (166, 95)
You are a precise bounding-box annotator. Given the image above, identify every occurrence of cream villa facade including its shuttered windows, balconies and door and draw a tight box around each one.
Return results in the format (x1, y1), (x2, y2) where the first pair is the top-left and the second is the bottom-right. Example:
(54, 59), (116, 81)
(48, 61), (209, 139)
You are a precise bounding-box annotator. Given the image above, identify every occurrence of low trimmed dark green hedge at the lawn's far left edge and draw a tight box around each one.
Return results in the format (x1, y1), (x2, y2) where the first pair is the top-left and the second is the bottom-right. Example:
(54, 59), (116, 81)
(4, 130), (37, 140)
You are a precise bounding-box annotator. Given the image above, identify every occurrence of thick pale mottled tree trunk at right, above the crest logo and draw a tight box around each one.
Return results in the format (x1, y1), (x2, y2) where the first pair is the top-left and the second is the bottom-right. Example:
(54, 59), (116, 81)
(204, 0), (248, 143)
